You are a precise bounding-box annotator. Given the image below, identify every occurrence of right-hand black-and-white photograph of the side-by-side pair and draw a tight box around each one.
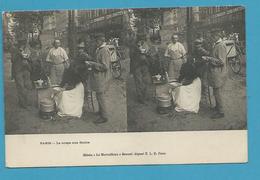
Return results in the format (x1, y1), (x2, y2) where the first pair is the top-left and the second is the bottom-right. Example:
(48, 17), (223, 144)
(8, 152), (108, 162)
(127, 6), (247, 132)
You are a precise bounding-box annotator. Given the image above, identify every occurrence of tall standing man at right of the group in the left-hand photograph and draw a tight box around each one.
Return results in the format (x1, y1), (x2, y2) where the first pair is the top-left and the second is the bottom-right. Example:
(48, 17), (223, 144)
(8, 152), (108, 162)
(85, 34), (111, 123)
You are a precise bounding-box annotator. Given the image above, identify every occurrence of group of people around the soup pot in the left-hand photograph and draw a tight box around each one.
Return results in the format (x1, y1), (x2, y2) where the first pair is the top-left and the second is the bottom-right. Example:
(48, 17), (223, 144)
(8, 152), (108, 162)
(11, 34), (111, 123)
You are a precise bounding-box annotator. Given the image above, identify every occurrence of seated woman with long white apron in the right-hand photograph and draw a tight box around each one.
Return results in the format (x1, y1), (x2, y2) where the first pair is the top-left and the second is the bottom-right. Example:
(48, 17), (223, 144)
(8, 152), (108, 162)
(172, 62), (201, 113)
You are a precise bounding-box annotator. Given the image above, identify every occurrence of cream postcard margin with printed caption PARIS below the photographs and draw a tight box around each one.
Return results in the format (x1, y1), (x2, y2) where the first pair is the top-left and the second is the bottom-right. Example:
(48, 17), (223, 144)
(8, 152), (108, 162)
(5, 130), (248, 168)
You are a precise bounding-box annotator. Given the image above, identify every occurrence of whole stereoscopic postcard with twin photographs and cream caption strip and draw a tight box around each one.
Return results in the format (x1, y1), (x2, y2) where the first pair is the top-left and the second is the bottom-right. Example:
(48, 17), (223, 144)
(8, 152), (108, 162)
(2, 6), (248, 168)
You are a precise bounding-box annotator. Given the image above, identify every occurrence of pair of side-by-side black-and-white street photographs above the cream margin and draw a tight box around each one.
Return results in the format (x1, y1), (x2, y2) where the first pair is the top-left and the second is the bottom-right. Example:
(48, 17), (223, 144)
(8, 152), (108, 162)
(3, 6), (247, 134)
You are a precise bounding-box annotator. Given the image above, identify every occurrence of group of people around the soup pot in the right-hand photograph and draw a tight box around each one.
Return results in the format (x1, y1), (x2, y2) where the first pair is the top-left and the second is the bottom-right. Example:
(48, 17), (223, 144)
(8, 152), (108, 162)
(130, 29), (227, 119)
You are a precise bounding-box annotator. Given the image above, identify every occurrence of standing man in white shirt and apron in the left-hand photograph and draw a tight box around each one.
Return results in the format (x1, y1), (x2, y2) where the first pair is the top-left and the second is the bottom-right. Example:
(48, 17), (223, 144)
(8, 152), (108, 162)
(46, 39), (69, 85)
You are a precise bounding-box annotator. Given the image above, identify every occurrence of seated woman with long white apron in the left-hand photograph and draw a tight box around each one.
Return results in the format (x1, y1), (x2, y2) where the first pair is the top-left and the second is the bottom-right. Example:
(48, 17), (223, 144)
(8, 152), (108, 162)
(54, 66), (84, 118)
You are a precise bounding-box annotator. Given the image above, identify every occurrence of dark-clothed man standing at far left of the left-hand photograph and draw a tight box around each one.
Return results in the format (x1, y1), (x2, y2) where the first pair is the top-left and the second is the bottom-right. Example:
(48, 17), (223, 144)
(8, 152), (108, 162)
(11, 40), (32, 109)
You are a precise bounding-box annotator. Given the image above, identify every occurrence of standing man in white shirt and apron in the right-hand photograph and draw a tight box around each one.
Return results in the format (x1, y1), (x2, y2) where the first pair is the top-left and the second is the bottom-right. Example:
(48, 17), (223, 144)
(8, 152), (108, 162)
(164, 34), (186, 80)
